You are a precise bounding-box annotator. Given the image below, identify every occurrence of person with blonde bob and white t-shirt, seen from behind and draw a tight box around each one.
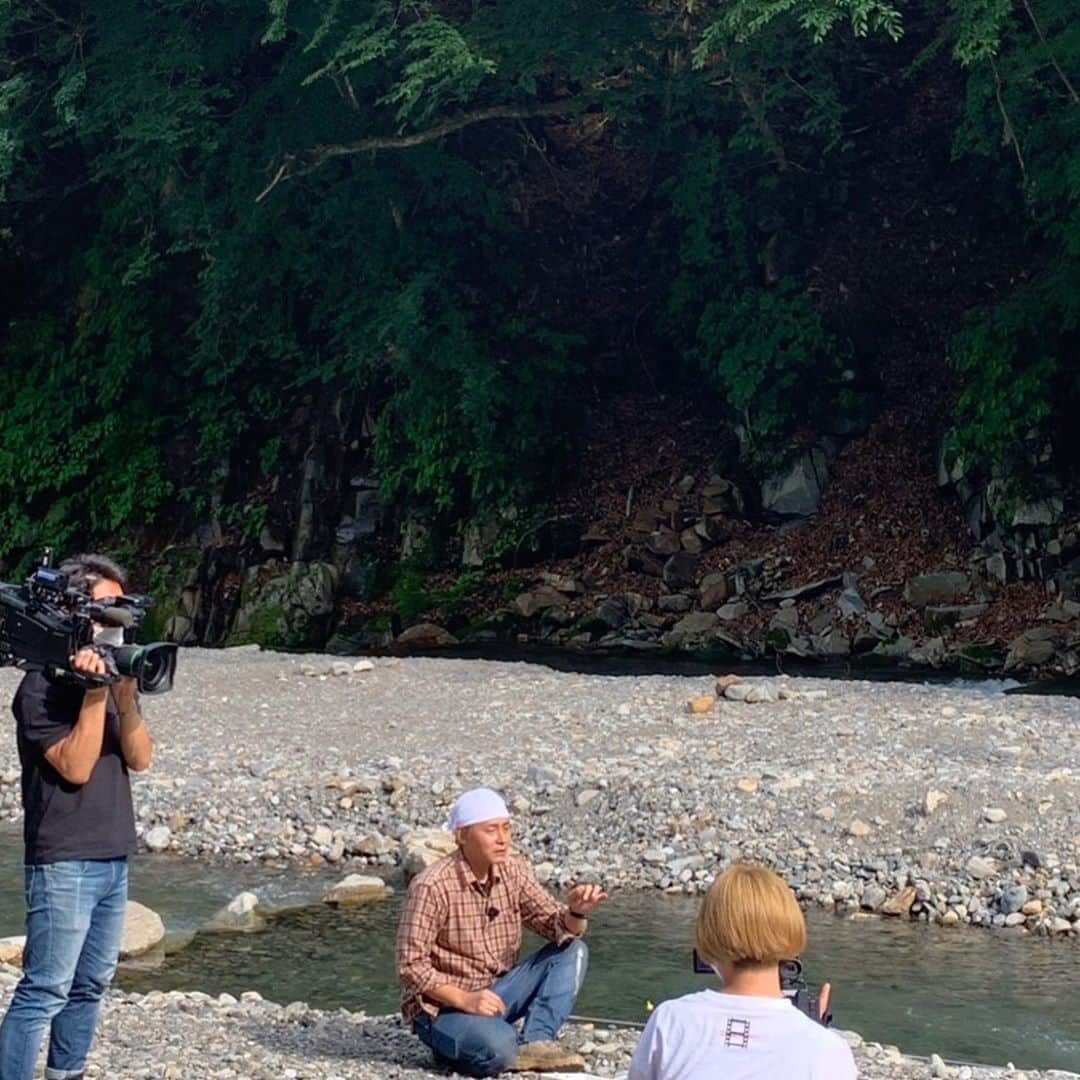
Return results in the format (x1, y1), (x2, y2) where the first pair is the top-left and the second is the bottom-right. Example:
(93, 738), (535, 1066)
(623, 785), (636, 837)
(627, 863), (858, 1080)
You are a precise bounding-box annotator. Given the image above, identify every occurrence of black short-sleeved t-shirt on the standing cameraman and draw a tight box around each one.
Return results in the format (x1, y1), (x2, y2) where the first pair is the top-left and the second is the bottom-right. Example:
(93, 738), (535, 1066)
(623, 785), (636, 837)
(12, 672), (135, 864)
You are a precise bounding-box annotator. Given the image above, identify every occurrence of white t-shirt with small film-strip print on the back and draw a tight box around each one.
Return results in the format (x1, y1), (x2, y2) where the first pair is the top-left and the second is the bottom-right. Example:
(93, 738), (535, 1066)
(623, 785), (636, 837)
(627, 990), (859, 1080)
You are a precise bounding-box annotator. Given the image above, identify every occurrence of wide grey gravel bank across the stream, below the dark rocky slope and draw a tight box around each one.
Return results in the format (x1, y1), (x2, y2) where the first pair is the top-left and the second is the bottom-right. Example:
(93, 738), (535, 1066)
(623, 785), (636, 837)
(0, 649), (1080, 937)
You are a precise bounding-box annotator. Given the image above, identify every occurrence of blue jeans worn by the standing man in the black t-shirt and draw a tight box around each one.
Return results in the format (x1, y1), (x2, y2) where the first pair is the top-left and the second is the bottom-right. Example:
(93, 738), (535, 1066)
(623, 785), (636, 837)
(0, 859), (127, 1080)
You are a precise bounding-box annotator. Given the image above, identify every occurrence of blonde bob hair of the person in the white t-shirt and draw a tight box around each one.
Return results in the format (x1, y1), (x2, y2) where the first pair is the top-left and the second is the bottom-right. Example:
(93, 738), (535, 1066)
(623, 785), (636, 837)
(696, 862), (807, 968)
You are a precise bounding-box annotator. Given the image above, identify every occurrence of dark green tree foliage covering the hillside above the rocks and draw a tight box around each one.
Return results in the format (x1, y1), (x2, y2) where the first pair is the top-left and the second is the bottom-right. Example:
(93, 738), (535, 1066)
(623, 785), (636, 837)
(0, 0), (1080, 557)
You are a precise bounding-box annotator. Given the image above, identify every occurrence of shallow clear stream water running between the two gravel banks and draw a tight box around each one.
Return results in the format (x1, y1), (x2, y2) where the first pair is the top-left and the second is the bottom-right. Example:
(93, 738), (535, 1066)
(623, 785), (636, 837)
(0, 842), (1080, 1069)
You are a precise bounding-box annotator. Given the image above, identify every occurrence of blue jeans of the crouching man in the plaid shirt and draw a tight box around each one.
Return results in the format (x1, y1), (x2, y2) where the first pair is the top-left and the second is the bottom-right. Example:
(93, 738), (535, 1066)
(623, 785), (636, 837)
(412, 940), (589, 1080)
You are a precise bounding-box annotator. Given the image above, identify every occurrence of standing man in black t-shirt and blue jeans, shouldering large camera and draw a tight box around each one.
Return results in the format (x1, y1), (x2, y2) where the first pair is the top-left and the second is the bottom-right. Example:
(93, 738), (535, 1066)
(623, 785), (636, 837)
(0, 555), (152, 1080)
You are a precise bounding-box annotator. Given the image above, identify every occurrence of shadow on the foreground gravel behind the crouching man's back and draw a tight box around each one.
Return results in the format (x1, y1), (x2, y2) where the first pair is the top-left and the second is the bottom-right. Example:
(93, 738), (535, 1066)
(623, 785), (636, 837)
(242, 1014), (443, 1075)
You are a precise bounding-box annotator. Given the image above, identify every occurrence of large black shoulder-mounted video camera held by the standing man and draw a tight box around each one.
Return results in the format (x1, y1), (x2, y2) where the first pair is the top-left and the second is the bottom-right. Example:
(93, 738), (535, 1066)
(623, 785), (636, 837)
(0, 549), (177, 693)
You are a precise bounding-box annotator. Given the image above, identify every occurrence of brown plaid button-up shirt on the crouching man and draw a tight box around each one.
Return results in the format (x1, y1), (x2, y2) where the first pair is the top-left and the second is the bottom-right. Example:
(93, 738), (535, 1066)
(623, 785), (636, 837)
(395, 851), (577, 1025)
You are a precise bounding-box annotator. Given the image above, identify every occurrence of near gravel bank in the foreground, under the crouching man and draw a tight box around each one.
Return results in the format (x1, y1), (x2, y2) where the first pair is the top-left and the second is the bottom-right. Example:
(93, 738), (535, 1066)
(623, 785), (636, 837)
(0, 980), (1076, 1080)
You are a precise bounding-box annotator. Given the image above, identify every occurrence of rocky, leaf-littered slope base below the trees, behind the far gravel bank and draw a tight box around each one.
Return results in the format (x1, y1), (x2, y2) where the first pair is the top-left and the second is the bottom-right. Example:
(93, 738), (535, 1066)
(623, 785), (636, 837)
(141, 390), (1080, 675)
